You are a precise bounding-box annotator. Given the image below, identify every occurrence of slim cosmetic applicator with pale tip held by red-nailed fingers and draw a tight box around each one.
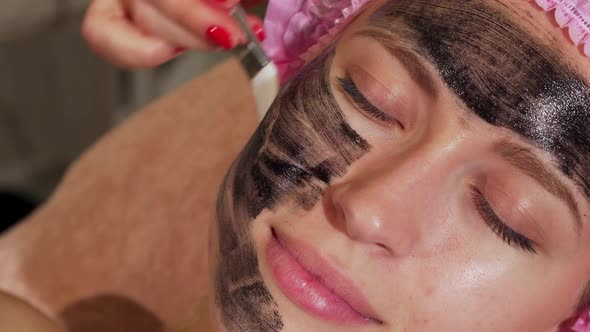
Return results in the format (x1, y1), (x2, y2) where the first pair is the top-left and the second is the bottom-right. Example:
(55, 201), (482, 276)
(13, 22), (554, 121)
(232, 4), (280, 119)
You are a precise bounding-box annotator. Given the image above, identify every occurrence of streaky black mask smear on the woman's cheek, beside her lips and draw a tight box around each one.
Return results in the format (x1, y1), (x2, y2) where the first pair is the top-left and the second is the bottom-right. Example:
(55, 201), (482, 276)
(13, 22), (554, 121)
(215, 51), (370, 332)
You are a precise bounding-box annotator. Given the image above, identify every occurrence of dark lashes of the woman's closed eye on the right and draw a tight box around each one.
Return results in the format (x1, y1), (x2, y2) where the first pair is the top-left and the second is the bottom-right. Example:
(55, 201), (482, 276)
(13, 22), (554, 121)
(471, 187), (537, 254)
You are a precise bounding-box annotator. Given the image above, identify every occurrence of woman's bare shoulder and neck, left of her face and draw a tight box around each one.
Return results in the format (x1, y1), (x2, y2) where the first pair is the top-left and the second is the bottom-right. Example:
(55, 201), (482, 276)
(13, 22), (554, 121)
(0, 60), (257, 332)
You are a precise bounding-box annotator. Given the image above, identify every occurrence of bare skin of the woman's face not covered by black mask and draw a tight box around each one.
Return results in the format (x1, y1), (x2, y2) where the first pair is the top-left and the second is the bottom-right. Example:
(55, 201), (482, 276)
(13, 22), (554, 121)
(210, 0), (590, 332)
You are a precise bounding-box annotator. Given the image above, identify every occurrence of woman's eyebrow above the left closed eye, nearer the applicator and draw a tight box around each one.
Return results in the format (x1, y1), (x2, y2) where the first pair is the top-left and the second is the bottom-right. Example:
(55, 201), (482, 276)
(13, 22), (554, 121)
(355, 27), (438, 97)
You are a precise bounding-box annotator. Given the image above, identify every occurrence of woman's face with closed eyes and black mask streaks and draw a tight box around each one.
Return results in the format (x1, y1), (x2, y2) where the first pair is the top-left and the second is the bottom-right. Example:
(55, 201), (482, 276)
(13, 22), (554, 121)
(212, 0), (590, 332)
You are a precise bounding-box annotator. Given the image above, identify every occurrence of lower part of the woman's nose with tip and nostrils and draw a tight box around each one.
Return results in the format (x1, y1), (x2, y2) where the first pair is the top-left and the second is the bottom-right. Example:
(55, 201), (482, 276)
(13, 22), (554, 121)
(324, 152), (449, 256)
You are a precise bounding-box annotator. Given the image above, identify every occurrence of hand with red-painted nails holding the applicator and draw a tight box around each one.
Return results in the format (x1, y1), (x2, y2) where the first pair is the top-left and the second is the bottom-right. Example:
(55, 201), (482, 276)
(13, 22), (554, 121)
(82, 0), (264, 68)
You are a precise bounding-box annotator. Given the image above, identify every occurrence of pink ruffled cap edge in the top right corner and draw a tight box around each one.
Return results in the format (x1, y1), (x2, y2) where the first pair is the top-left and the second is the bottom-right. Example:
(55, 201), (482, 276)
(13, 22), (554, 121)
(535, 0), (590, 55)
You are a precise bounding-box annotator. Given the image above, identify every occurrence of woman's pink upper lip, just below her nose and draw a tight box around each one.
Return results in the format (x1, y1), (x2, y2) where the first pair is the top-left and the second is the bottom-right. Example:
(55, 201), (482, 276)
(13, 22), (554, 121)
(272, 228), (383, 324)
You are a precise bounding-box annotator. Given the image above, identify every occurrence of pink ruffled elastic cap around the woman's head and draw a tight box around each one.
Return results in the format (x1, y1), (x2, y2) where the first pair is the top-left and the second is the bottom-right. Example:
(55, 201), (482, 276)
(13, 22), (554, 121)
(263, 0), (590, 82)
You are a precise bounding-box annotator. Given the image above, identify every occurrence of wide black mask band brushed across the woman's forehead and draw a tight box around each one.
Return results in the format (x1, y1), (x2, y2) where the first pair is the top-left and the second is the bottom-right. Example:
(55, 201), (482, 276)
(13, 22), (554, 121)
(369, 0), (590, 197)
